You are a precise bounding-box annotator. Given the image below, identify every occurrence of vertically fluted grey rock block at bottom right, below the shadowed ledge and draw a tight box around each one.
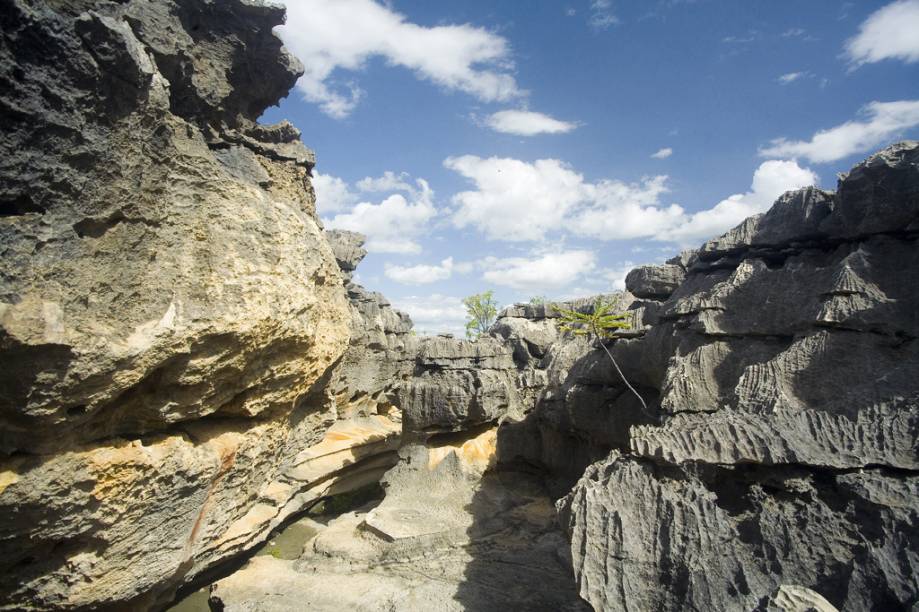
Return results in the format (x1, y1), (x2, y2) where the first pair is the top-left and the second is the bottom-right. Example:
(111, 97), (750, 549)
(560, 452), (919, 610)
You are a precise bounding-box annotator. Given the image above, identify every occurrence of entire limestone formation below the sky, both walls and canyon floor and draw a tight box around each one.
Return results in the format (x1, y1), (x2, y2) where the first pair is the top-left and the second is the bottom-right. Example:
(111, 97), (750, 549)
(0, 0), (919, 610)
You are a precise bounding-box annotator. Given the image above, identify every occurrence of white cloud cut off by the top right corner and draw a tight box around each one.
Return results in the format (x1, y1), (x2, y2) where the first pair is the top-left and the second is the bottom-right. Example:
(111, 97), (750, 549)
(846, 0), (919, 66)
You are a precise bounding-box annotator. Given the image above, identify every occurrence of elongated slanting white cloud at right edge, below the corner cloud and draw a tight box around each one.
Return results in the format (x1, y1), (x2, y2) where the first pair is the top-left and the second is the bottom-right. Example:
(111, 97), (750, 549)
(759, 100), (919, 164)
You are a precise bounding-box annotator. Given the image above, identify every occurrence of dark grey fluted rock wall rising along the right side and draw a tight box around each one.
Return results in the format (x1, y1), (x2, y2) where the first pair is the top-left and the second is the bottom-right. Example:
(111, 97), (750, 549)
(556, 142), (919, 610)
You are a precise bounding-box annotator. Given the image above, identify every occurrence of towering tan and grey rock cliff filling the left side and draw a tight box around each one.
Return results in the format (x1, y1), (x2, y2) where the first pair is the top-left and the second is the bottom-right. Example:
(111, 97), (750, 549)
(0, 0), (360, 609)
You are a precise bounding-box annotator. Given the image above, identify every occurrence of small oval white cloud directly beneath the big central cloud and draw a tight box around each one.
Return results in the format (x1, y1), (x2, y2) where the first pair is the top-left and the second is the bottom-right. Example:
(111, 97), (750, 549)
(481, 250), (596, 292)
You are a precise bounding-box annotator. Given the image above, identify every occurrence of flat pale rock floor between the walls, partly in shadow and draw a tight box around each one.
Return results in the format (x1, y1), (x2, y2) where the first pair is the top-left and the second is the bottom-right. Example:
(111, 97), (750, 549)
(211, 428), (588, 612)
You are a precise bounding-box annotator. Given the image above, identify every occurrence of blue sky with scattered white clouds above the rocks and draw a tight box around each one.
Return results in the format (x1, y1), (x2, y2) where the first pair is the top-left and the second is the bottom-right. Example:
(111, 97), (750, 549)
(264, 0), (919, 333)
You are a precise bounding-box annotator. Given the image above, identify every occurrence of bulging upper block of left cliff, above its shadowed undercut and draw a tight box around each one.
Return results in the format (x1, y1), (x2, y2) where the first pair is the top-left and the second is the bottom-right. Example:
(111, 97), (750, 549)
(0, 0), (348, 453)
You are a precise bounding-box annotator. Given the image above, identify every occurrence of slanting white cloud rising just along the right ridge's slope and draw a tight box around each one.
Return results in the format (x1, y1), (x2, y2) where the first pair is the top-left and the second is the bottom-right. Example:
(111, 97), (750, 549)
(658, 160), (817, 246)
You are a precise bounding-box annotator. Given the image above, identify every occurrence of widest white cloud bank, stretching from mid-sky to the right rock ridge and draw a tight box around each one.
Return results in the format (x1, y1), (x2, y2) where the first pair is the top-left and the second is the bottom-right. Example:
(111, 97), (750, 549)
(446, 156), (817, 246)
